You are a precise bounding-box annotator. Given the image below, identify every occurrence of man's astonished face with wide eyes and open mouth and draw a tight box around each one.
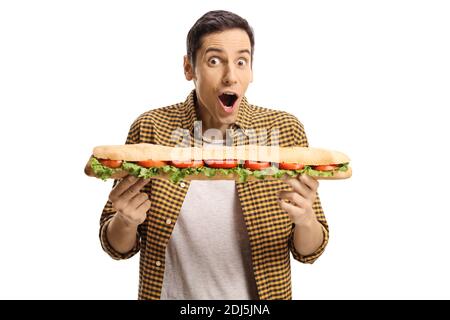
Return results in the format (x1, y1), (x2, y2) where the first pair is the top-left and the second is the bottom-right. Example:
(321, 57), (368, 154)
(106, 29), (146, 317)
(184, 29), (253, 129)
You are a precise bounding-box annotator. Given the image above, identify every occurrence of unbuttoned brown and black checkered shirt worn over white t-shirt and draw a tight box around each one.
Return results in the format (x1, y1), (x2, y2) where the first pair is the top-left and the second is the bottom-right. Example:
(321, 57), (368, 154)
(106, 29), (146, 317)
(100, 90), (328, 300)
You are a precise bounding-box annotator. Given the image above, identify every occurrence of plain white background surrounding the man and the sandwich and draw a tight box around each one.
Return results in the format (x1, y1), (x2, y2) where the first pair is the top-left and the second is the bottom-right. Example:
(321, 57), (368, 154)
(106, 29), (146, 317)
(0, 0), (450, 299)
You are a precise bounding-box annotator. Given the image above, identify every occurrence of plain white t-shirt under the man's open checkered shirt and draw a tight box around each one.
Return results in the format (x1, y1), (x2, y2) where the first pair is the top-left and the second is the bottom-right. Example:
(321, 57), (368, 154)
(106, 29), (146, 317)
(161, 140), (258, 300)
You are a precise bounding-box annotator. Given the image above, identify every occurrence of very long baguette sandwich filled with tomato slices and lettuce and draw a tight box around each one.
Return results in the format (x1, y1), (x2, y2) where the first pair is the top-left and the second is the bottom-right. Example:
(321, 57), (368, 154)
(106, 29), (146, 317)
(85, 143), (352, 183)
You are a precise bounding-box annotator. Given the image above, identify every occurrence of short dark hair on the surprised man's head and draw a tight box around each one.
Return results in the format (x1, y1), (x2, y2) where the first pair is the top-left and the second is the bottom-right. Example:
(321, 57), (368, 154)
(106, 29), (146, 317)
(186, 10), (255, 67)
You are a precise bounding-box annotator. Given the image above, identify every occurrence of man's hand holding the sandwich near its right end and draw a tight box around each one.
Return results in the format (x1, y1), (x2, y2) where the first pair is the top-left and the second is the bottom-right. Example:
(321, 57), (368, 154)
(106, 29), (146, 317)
(278, 174), (319, 227)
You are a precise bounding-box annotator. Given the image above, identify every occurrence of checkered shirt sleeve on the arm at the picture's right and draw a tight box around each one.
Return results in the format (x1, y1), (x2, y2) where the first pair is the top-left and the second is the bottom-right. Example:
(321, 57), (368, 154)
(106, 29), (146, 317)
(289, 117), (329, 263)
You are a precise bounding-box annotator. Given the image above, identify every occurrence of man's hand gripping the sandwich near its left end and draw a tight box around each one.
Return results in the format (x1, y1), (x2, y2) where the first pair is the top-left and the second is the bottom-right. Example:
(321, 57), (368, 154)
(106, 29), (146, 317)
(109, 175), (150, 227)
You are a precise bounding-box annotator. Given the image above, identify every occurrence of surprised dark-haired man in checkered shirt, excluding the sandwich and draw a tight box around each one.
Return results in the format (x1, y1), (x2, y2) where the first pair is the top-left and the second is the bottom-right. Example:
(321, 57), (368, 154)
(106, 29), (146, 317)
(100, 11), (328, 299)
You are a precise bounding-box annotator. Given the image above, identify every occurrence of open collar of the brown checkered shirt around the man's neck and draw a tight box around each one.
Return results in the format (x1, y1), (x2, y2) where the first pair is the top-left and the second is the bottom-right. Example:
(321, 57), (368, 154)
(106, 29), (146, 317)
(183, 90), (252, 135)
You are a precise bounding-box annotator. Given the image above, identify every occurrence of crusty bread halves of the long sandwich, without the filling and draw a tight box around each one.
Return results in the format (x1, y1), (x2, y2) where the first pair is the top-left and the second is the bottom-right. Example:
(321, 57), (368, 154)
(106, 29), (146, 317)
(85, 143), (352, 181)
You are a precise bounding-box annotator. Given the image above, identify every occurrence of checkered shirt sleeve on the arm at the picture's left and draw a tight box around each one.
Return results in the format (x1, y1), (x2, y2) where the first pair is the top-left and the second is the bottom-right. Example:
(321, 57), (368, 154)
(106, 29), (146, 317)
(99, 118), (141, 260)
